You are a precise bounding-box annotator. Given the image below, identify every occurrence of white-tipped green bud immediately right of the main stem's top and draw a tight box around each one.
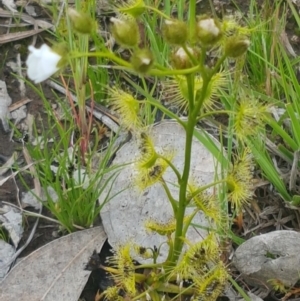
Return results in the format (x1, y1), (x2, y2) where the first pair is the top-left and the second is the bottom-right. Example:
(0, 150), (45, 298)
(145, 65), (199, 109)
(196, 18), (222, 46)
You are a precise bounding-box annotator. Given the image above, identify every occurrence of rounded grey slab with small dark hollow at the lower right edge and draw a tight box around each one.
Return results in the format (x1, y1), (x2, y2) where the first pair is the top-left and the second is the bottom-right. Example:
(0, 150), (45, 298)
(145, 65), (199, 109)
(233, 230), (300, 289)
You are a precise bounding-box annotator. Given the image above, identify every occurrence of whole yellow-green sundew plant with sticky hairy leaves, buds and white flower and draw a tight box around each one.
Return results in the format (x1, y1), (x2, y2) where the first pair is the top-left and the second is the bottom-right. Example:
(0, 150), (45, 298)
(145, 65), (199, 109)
(27, 0), (267, 300)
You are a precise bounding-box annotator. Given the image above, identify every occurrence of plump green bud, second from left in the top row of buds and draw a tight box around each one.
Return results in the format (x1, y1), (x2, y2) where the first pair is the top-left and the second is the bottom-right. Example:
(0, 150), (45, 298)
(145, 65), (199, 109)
(110, 17), (140, 48)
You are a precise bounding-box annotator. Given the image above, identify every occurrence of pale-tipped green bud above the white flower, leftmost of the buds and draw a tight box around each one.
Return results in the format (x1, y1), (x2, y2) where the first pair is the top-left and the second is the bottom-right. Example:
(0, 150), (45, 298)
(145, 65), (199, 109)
(68, 8), (95, 34)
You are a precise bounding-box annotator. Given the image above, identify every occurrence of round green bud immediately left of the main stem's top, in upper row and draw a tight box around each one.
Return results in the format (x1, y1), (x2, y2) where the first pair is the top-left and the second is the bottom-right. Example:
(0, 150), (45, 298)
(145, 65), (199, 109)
(162, 20), (188, 45)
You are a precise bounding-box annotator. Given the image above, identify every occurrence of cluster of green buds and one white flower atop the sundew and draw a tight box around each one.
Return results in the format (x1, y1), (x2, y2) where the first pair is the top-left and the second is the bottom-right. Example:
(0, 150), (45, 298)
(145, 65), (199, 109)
(26, 8), (250, 83)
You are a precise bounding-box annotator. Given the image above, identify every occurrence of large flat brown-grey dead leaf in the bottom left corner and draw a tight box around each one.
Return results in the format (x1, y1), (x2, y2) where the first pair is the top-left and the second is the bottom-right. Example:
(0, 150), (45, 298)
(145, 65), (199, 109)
(0, 227), (106, 301)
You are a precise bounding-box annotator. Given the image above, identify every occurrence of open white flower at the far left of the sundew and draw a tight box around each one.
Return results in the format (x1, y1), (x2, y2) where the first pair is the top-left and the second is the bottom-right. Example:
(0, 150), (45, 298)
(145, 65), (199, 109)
(26, 44), (61, 84)
